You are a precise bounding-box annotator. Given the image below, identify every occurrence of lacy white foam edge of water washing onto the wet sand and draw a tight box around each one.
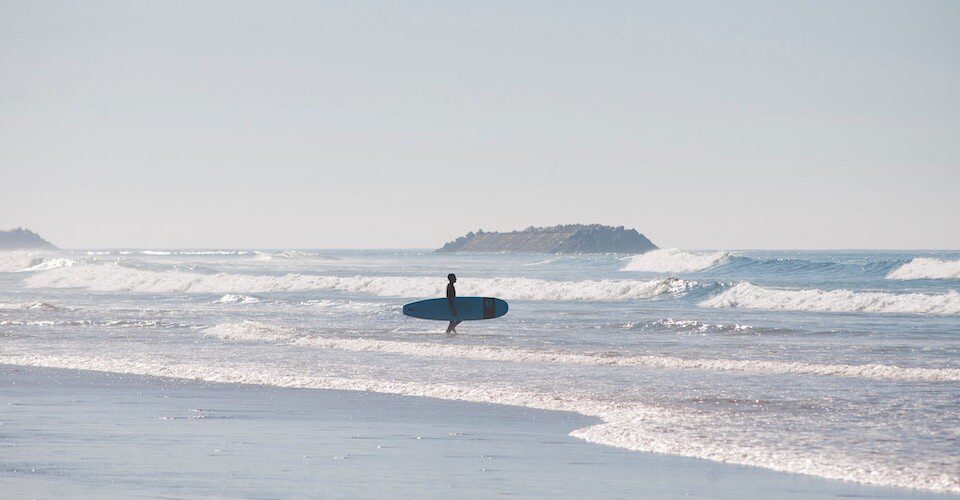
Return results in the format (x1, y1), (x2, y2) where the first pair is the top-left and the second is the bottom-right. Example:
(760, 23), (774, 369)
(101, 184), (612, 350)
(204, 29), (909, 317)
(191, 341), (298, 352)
(0, 354), (960, 493)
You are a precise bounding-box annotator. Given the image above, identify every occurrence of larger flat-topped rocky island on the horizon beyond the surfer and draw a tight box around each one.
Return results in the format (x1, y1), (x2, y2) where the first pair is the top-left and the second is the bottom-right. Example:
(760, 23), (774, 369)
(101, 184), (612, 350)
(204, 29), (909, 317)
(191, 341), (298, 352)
(437, 224), (657, 253)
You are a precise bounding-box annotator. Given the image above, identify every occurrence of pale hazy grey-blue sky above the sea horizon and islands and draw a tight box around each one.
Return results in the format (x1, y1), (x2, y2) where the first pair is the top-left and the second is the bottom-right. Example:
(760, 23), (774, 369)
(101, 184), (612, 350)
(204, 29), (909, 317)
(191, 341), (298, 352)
(0, 0), (960, 249)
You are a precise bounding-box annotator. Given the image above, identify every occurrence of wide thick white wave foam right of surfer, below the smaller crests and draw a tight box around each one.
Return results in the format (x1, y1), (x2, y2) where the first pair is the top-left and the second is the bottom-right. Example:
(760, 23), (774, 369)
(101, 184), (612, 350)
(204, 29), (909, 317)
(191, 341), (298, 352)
(700, 282), (960, 315)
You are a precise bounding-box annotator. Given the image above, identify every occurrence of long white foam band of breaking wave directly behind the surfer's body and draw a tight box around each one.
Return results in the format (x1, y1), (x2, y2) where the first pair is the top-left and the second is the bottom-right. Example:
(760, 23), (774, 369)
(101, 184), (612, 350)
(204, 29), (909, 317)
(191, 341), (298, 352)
(25, 264), (697, 301)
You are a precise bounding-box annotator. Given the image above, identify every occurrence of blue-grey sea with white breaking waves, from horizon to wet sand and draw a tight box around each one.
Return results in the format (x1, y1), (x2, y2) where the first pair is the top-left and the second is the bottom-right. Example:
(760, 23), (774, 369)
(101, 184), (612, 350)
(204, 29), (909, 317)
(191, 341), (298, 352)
(0, 250), (960, 493)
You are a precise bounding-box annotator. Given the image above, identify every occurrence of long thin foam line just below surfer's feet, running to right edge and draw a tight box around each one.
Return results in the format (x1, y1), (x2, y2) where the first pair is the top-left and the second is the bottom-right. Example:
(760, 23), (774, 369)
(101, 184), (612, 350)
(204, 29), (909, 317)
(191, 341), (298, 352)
(293, 336), (960, 382)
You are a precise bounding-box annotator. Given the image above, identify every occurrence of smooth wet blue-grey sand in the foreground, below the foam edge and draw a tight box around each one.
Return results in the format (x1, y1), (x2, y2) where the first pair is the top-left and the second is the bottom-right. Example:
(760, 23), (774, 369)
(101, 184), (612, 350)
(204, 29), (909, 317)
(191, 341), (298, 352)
(0, 364), (952, 499)
